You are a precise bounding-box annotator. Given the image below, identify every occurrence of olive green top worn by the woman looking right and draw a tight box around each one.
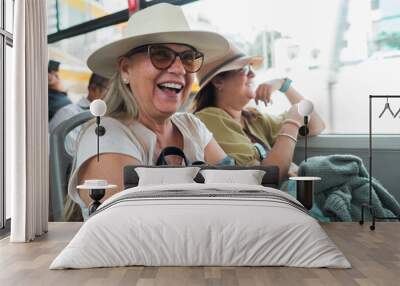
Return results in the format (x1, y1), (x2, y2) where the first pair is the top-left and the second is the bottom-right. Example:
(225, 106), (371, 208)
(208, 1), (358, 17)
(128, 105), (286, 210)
(195, 107), (287, 166)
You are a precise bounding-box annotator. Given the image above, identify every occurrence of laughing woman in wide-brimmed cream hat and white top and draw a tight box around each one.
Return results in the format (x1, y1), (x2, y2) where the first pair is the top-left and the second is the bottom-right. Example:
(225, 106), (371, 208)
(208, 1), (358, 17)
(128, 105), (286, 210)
(66, 4), (229, 218)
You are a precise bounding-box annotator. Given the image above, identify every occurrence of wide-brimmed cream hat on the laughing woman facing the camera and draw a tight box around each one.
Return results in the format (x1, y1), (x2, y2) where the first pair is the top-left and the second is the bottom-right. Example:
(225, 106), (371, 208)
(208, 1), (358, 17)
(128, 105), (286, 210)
(87, 3), (229, 78)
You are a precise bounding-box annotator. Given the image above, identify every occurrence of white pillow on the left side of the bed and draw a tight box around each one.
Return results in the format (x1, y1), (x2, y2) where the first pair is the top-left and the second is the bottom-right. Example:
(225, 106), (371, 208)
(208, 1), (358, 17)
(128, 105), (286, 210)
(135, 167), (200, 186)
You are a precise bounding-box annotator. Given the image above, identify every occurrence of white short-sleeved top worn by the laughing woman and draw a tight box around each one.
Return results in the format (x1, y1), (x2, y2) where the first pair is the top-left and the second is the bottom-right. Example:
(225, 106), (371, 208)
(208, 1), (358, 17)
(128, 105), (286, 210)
(68, 112), (213, 209)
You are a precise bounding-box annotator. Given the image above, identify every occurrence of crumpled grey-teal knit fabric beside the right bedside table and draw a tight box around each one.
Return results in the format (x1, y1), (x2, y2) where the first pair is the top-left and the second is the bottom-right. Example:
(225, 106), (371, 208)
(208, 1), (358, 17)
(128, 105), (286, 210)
(299, 155), (400, 221)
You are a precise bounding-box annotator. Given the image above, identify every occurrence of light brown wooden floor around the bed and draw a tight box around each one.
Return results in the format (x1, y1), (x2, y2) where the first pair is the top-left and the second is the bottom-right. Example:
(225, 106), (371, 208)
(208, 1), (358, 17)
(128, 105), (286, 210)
(0, 222), (400, 286)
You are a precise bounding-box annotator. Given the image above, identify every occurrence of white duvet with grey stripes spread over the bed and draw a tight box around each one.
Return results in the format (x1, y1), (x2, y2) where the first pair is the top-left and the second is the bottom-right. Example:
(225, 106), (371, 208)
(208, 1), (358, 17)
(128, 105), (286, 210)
(50, 183), (351, 269)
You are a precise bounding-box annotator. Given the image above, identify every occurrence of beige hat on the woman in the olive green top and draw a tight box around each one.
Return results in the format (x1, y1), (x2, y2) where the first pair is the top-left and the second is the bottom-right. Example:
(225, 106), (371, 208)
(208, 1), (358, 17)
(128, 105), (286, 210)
(197, 45), (263, 90)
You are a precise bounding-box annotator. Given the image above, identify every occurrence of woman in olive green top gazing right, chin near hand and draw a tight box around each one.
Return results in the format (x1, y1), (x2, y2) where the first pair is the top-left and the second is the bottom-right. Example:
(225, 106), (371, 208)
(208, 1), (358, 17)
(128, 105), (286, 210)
(193, 44), (324, 179)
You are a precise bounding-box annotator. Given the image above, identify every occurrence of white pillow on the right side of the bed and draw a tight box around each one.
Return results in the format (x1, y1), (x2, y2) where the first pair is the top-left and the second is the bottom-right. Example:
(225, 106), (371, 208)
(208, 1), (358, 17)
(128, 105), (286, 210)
(200, 169), (265, 185)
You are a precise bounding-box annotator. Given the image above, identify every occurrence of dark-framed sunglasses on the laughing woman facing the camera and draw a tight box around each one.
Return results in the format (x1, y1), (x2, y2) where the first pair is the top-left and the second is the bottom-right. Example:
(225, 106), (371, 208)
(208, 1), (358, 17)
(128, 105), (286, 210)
(125, 45), (204, 73)
